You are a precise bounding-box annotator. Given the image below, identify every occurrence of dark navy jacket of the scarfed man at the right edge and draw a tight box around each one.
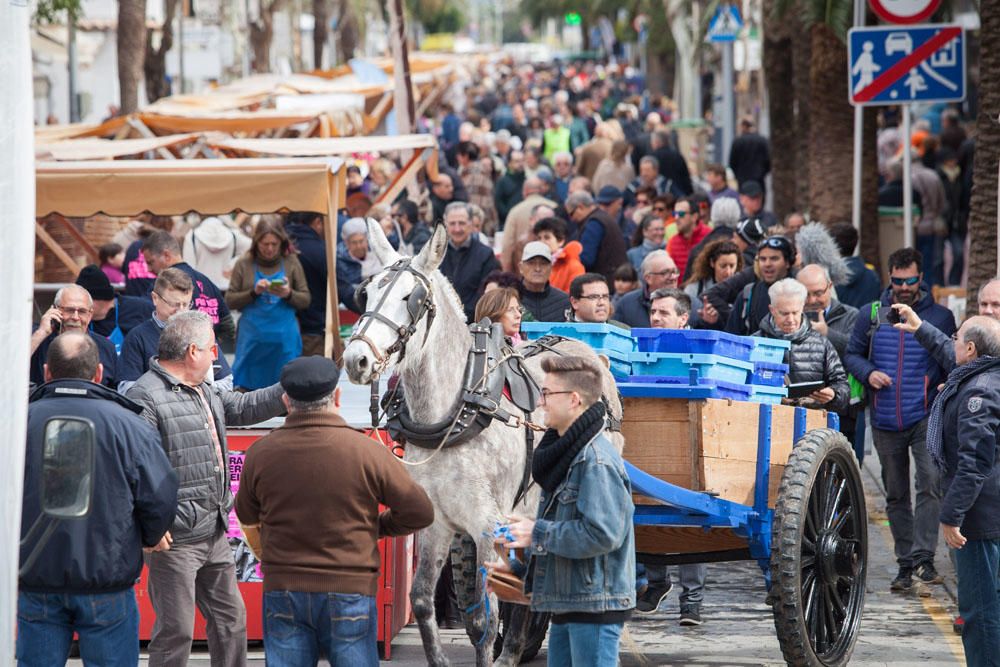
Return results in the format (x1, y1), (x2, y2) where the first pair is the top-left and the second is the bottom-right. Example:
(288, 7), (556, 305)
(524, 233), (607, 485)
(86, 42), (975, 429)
(941, 360), (1000, 540)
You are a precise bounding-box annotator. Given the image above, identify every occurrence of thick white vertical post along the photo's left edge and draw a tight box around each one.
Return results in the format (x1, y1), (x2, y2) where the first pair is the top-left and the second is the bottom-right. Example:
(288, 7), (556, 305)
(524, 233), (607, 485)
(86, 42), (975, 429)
(0, 2), (35, 665)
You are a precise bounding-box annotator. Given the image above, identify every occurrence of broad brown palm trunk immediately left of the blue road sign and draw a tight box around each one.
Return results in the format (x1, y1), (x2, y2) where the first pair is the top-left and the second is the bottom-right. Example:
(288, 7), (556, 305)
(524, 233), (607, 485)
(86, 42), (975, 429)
(804, 24), (854, 223)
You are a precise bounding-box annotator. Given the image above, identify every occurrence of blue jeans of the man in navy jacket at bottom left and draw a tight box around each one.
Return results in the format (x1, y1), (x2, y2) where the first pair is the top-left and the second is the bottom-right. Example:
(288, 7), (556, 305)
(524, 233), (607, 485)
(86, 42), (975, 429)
(17, 588), (139, 667)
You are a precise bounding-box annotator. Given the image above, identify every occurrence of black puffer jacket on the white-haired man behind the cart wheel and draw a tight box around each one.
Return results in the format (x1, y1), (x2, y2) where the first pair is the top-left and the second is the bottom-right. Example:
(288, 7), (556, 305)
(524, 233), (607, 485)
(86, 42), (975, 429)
(754, 315), (851, 412)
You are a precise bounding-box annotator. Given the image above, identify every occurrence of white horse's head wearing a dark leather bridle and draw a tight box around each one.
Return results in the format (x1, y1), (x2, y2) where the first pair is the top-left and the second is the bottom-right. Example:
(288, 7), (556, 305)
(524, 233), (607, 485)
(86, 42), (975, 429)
(344, 219), (448, 384)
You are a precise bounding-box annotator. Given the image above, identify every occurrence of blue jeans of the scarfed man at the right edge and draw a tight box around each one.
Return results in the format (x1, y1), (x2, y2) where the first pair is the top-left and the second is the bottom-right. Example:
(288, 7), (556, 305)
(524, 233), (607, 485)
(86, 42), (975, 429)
(955, 540), (1000, 667)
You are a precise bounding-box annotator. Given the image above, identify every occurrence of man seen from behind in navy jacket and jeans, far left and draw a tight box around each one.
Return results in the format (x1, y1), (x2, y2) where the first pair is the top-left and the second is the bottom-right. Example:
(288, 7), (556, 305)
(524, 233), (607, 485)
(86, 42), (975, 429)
(17, 332), (177, 667)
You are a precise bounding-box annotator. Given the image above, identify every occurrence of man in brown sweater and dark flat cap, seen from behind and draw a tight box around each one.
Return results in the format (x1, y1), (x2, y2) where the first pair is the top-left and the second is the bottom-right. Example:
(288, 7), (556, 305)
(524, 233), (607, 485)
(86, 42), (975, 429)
(236, 357), (434, 667)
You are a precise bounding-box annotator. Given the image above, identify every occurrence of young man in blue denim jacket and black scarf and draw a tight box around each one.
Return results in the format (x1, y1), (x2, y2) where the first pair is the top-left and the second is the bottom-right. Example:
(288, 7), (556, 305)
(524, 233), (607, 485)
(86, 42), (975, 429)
(490, 357), (635, 667)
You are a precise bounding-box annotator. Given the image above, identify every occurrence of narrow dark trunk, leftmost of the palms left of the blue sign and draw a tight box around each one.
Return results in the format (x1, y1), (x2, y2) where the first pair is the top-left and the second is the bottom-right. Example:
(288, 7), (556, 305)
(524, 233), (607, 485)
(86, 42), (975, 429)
(762, 0), (799, 220)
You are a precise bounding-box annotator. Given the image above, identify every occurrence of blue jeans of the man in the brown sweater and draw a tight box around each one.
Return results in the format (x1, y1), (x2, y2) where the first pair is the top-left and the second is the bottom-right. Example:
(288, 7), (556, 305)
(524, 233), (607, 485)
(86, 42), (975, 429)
(264, 591), (378, 667)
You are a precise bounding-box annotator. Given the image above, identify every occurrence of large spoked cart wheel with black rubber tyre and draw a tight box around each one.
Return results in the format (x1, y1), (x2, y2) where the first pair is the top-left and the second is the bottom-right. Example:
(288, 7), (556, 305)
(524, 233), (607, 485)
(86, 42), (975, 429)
(771, 429), (868, 667)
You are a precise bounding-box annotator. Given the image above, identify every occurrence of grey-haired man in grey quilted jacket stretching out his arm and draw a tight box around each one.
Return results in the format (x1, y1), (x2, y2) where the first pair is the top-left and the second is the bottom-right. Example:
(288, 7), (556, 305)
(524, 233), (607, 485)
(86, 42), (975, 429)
(127, 310), (285, 667)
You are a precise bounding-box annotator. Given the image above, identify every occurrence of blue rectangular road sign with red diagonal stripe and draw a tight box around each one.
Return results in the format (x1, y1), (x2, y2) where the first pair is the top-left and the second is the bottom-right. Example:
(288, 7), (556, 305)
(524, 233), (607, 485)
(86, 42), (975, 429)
(847, 24), (965, 106)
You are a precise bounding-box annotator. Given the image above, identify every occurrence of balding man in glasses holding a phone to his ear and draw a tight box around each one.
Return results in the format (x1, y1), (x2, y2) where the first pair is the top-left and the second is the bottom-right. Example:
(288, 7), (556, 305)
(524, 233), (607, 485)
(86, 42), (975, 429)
(29, 285), (118, 388)
